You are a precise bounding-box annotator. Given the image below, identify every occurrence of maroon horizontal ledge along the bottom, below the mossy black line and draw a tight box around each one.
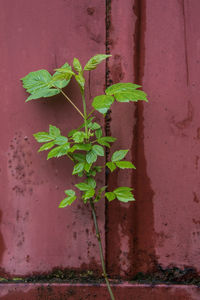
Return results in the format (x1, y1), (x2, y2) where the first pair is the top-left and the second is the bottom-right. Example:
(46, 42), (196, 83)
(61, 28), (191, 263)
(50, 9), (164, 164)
(0, 283), (200, 300)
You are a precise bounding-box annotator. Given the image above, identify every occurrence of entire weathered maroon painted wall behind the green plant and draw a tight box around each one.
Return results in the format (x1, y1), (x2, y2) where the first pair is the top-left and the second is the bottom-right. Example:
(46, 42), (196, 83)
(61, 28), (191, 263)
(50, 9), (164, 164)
(0, 0), (200, 300)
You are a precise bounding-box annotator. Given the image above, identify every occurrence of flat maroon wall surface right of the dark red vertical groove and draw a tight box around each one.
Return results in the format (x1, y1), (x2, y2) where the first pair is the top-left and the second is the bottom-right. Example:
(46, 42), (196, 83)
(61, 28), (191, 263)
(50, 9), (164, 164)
(141, 0), (200, 272)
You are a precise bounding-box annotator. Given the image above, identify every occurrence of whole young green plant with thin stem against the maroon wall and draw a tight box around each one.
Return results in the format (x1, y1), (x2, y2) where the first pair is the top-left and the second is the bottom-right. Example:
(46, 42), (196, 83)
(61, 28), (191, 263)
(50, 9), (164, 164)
(22, 54), (147, 300)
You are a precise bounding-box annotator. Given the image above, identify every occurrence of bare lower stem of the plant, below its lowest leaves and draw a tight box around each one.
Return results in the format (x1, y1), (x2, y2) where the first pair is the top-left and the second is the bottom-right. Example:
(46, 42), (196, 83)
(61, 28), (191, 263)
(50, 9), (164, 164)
(90, 199), (115, 300)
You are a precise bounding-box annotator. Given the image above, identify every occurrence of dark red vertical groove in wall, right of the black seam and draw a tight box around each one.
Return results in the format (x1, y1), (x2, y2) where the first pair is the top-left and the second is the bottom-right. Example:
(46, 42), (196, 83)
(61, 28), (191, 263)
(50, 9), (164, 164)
(132, 0), (156, 274)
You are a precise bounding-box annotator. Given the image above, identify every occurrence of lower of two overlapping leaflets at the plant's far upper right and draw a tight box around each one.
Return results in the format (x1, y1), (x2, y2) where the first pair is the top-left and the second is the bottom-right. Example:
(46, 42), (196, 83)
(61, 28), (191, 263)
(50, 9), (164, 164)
(114, 90), (148, 102)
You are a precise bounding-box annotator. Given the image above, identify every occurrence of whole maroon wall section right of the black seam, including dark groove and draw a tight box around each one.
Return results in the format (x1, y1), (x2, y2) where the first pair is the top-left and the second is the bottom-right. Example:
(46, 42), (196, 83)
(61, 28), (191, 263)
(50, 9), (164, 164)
(107, 0), (200, 277)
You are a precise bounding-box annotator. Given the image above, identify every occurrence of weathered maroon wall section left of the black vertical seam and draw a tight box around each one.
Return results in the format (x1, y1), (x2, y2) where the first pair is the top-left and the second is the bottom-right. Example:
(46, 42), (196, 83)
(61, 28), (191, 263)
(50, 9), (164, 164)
(0, 0), (105, 277)
